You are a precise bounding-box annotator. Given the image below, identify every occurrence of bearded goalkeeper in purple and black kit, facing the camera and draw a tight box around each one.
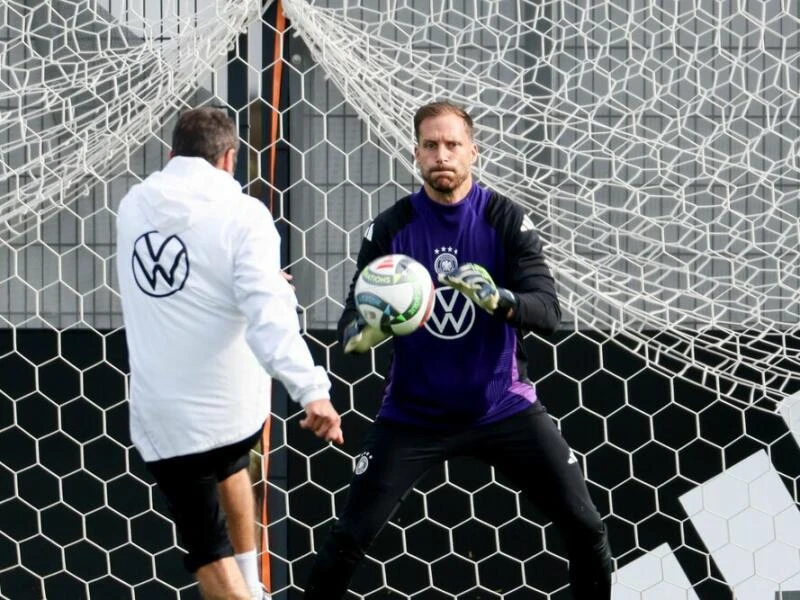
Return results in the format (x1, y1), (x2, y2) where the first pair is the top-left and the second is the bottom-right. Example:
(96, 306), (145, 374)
(304, 102), (612, 600)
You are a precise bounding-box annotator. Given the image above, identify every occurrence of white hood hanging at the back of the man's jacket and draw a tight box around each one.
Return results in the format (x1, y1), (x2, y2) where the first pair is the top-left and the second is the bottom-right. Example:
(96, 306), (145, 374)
(138, 156), (242, 234)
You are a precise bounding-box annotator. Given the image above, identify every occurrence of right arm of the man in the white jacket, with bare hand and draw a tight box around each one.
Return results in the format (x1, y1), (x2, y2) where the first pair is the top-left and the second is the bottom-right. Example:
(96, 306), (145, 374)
(233, 202), (343, 444)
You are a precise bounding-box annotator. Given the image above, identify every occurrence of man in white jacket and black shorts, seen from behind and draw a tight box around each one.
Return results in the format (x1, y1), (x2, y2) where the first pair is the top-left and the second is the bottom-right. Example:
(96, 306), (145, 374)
(117, 107), (343, 600)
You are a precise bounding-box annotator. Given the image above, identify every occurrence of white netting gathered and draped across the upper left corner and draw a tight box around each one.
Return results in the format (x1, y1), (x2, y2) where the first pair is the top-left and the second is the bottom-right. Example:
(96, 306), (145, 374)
(0, 0), (261, 235)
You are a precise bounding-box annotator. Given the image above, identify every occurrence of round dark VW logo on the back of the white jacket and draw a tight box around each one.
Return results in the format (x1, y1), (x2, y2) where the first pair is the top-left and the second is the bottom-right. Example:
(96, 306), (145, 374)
(131, 231), (189, 298)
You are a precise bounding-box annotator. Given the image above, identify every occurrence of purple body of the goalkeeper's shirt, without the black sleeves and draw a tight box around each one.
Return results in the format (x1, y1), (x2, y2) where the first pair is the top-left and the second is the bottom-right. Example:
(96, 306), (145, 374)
(378, 184), (536, 428)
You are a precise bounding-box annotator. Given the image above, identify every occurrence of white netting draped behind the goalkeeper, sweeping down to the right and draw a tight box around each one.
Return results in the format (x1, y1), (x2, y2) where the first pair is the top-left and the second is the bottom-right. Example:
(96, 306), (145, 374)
(285, 0), (800, 402)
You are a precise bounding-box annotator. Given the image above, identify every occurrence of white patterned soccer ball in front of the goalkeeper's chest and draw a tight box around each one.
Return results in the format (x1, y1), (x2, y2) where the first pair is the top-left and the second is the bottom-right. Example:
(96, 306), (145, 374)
(354, 254), (436, 335)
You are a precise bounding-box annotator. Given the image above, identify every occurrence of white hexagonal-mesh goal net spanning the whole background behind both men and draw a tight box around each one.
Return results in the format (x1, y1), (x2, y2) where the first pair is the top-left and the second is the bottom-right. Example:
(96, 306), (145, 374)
(0, 0), (800, 600)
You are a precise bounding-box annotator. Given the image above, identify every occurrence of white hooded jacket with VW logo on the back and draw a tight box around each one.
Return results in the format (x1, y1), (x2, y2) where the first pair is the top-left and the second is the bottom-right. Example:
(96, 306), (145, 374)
(117, 156), (330, 462)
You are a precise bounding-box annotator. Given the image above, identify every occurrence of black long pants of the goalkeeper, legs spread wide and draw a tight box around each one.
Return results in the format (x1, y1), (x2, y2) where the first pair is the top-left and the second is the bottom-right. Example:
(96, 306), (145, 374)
(304, 402), (612, 600)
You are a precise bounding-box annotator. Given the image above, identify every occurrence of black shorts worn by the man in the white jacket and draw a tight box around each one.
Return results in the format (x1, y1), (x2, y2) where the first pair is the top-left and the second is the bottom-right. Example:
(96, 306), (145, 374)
(147, 429), (261, 573)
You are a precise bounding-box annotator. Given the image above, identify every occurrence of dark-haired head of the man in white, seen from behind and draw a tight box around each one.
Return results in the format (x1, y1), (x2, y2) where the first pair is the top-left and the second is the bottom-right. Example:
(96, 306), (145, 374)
(172, 106), (239, 165)
